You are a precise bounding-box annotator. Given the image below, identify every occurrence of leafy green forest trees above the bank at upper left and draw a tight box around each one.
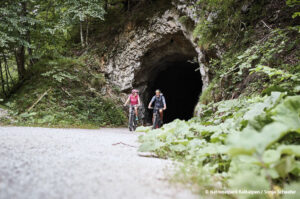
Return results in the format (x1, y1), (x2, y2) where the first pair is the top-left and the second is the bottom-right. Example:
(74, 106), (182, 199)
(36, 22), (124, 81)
(0, 0), (105, 96)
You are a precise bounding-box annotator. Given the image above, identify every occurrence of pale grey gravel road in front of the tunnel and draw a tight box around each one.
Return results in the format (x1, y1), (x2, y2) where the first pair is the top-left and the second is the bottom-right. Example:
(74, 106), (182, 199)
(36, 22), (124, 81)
(0, 127), (197, 199)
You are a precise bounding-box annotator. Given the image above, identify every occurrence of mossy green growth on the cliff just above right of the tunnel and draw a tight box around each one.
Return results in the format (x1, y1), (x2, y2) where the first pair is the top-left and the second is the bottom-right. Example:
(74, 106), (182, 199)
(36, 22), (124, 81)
(193, 0), (256, 49)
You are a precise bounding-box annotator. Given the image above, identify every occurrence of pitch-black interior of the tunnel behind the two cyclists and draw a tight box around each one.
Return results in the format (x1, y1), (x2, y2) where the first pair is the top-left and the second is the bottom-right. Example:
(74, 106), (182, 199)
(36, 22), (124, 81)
(144, 61), (202, 123)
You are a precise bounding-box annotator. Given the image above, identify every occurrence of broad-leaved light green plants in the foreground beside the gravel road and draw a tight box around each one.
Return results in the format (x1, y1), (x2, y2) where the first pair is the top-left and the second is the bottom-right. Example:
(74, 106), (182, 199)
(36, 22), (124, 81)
(140, 92), (300, 198)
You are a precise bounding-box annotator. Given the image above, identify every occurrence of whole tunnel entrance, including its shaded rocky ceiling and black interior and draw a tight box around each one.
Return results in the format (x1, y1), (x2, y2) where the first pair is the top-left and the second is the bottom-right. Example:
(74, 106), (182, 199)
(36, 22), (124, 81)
(133, 33), (202, 123)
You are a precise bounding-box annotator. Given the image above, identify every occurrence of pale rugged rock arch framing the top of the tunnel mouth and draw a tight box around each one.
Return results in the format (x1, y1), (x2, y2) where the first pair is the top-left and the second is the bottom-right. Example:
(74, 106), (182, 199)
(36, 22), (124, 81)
(104, 8), (208, 92)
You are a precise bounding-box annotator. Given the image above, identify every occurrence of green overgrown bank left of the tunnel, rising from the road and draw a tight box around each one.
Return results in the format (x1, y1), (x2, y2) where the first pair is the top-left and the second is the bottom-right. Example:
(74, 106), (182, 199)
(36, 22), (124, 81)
(0, 56), (125, 128)
